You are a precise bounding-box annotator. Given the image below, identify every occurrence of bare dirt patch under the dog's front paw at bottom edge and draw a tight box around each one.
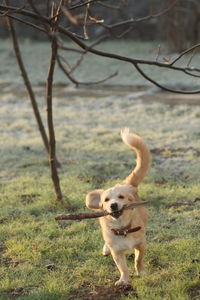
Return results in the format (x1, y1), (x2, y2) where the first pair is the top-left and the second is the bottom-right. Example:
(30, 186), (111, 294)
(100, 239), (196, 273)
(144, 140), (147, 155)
(68, 285), (138, 300)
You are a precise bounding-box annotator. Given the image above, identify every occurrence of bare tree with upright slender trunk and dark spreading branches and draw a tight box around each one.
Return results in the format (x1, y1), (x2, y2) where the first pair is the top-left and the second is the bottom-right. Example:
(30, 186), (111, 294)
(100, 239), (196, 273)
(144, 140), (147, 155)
(0, 0), (200, 200)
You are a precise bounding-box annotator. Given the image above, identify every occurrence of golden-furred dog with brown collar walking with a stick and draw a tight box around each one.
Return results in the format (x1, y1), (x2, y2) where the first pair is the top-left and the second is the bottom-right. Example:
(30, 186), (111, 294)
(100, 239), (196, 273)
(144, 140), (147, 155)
(86, 128), (151, 285)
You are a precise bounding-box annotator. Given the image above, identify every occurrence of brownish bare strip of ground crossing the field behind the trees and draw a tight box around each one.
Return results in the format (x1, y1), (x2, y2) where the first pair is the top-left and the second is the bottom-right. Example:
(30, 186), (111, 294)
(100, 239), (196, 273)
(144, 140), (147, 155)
(3, 84), (200, 106)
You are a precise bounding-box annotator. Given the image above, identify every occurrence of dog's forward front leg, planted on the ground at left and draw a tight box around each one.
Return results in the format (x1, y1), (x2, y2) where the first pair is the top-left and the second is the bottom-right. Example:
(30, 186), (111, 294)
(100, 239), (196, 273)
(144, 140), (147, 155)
(111, 250), (129, 285)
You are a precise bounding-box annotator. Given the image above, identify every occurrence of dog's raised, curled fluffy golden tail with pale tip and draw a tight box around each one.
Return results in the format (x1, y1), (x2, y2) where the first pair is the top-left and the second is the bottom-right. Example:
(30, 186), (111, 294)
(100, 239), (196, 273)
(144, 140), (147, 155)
(121, 128), (151, 187)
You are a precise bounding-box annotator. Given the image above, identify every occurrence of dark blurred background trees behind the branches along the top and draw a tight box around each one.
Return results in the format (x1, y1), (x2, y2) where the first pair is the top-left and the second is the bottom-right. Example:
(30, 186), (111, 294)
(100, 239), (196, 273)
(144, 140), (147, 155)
(0, 0), (200, 52)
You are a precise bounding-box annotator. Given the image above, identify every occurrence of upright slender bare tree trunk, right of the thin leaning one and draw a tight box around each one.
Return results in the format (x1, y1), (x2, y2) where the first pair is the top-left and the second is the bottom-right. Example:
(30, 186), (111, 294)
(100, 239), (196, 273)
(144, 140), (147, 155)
(46, 32), (62, 200)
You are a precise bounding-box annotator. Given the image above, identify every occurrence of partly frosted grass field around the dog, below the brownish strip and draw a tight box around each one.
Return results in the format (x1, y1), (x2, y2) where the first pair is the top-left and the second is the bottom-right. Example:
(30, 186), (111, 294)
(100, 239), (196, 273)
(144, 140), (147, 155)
(0, 40), (200, 300)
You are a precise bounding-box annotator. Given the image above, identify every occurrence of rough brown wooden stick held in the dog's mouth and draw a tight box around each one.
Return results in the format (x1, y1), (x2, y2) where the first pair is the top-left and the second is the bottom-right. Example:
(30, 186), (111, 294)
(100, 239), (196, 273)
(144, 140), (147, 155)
(55, 201), (150, 221)
